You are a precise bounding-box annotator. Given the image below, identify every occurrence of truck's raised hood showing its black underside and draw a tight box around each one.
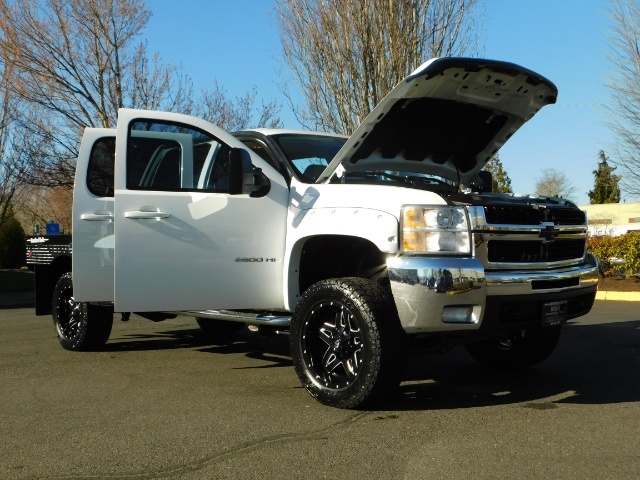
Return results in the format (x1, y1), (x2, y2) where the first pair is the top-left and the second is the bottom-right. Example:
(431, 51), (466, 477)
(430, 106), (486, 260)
(318, 58), (558, 187)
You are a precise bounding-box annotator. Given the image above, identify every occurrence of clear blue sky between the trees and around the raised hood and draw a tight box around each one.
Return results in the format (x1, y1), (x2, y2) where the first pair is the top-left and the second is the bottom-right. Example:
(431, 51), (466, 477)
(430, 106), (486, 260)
(144, 0), (620, 205)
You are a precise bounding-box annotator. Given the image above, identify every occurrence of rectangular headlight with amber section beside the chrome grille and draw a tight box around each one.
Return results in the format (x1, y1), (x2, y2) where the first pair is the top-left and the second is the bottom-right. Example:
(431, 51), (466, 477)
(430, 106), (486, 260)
(401, 206), (471, 255)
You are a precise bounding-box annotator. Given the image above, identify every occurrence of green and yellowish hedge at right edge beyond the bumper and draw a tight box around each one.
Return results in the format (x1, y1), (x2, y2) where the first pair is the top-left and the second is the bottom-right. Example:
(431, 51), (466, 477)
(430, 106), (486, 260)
(587, 232), (640, 277)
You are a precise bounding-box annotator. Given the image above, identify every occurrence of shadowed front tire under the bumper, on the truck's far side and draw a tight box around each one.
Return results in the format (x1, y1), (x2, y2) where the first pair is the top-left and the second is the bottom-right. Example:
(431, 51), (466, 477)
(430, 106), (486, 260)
(466, 327), (561, 371)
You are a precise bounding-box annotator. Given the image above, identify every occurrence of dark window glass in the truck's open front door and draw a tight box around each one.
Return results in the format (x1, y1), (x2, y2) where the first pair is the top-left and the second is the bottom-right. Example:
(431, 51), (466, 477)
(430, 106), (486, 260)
(127, 120), (230, 192)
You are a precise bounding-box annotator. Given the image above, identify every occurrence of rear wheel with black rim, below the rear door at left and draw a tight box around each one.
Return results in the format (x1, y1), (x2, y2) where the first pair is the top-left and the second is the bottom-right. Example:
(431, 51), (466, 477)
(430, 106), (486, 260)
(52, 273), (113, 351)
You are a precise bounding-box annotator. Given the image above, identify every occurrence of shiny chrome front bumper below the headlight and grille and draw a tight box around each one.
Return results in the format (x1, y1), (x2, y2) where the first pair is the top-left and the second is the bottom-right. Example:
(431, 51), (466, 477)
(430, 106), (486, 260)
(387, 254), (598, 334)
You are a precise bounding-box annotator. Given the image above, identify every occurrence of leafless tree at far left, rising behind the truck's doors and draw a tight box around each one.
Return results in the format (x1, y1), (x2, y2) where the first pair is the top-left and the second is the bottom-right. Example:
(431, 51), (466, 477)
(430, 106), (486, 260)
(0, 0), (192, 186)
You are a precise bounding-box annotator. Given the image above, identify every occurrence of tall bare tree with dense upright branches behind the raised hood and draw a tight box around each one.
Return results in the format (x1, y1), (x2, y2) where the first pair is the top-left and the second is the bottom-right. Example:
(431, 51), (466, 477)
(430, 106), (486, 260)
(275, 0), (483, 134)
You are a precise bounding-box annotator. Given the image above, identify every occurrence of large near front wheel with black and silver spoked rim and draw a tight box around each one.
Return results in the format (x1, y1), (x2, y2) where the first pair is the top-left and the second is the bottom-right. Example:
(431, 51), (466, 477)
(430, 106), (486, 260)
(290, 278), (405, 408)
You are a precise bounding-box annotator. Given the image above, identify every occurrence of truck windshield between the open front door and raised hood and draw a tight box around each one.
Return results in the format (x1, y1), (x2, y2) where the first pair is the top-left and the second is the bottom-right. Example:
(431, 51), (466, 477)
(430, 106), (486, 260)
(274, 134), (347, 183)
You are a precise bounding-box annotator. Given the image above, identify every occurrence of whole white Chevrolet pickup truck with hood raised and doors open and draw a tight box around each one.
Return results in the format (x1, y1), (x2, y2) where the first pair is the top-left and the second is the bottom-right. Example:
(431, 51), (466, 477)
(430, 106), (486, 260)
(27, 58), (597, 408)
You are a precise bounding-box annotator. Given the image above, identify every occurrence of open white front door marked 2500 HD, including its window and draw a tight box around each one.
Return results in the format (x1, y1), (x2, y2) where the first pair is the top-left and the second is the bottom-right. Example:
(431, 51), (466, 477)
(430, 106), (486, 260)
(114, 109), (288, 311)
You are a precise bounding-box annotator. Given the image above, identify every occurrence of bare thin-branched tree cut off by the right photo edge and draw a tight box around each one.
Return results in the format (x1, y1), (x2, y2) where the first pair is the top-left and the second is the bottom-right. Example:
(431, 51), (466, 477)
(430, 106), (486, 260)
(608, 0), (640, 196)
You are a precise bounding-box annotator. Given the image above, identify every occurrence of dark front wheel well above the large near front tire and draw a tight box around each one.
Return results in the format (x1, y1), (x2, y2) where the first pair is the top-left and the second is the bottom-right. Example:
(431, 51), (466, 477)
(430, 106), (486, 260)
(299, 235), (388, 292)
